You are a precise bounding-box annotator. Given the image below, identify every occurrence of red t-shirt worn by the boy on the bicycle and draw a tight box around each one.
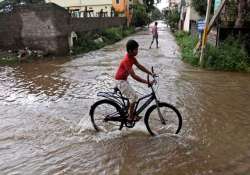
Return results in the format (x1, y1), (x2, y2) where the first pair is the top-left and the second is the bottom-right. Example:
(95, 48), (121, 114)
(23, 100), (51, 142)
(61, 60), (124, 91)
(115, 54), (136, 80)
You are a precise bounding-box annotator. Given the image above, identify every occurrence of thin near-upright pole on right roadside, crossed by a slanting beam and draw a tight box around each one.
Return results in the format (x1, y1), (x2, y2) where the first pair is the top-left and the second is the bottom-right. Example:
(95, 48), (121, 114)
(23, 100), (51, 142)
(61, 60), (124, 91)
(199, 0), (212, 66)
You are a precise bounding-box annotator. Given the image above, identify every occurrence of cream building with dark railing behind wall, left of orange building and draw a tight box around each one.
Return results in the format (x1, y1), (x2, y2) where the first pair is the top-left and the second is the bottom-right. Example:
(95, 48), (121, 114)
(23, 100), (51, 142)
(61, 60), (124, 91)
(46, 0), (112, 17)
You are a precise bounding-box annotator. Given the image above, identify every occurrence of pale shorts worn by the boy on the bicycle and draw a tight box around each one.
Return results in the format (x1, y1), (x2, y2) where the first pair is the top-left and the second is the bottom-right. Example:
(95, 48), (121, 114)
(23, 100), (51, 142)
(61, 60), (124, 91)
(116, 80), (138, 103)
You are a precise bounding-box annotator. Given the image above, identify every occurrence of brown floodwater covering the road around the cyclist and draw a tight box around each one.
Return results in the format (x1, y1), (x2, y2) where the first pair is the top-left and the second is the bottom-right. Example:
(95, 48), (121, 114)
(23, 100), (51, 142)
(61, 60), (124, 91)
(0, 24), (250, 175)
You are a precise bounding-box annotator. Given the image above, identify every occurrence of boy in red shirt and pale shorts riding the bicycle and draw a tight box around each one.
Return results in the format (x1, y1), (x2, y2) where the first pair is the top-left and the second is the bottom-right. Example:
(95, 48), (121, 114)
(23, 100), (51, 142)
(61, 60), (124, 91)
(115, 40), (153, 125)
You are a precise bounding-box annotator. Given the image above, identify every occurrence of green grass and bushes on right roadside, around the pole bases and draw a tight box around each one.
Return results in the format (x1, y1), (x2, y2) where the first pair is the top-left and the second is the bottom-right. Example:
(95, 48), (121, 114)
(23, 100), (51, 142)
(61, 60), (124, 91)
(174, 31), (250, 72)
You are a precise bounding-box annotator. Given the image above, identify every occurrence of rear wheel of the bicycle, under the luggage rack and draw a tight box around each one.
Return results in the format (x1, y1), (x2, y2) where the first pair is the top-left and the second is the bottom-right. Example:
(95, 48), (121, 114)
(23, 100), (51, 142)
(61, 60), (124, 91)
(90, 99), (122, 132)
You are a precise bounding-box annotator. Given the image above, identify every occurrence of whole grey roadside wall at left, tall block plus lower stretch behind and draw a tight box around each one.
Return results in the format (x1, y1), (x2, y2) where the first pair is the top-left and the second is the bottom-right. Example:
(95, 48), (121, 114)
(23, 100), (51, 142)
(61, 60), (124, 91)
(0, 3), (126, 55)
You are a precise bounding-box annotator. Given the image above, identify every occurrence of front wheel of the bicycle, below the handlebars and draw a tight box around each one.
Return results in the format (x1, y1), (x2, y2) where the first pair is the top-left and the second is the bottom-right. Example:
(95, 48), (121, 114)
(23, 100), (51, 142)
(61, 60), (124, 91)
(144, 103), (182, 135)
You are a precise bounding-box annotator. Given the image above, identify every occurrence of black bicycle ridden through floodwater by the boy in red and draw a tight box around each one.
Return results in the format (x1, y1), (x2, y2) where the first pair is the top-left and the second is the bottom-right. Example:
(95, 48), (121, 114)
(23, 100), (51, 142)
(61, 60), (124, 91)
(89, 67), (182, 136)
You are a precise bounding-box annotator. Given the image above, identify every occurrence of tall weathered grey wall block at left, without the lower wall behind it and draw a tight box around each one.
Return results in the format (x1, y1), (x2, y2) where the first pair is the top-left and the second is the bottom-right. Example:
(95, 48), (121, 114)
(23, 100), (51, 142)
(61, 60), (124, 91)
(0, 4), (70, 55)
